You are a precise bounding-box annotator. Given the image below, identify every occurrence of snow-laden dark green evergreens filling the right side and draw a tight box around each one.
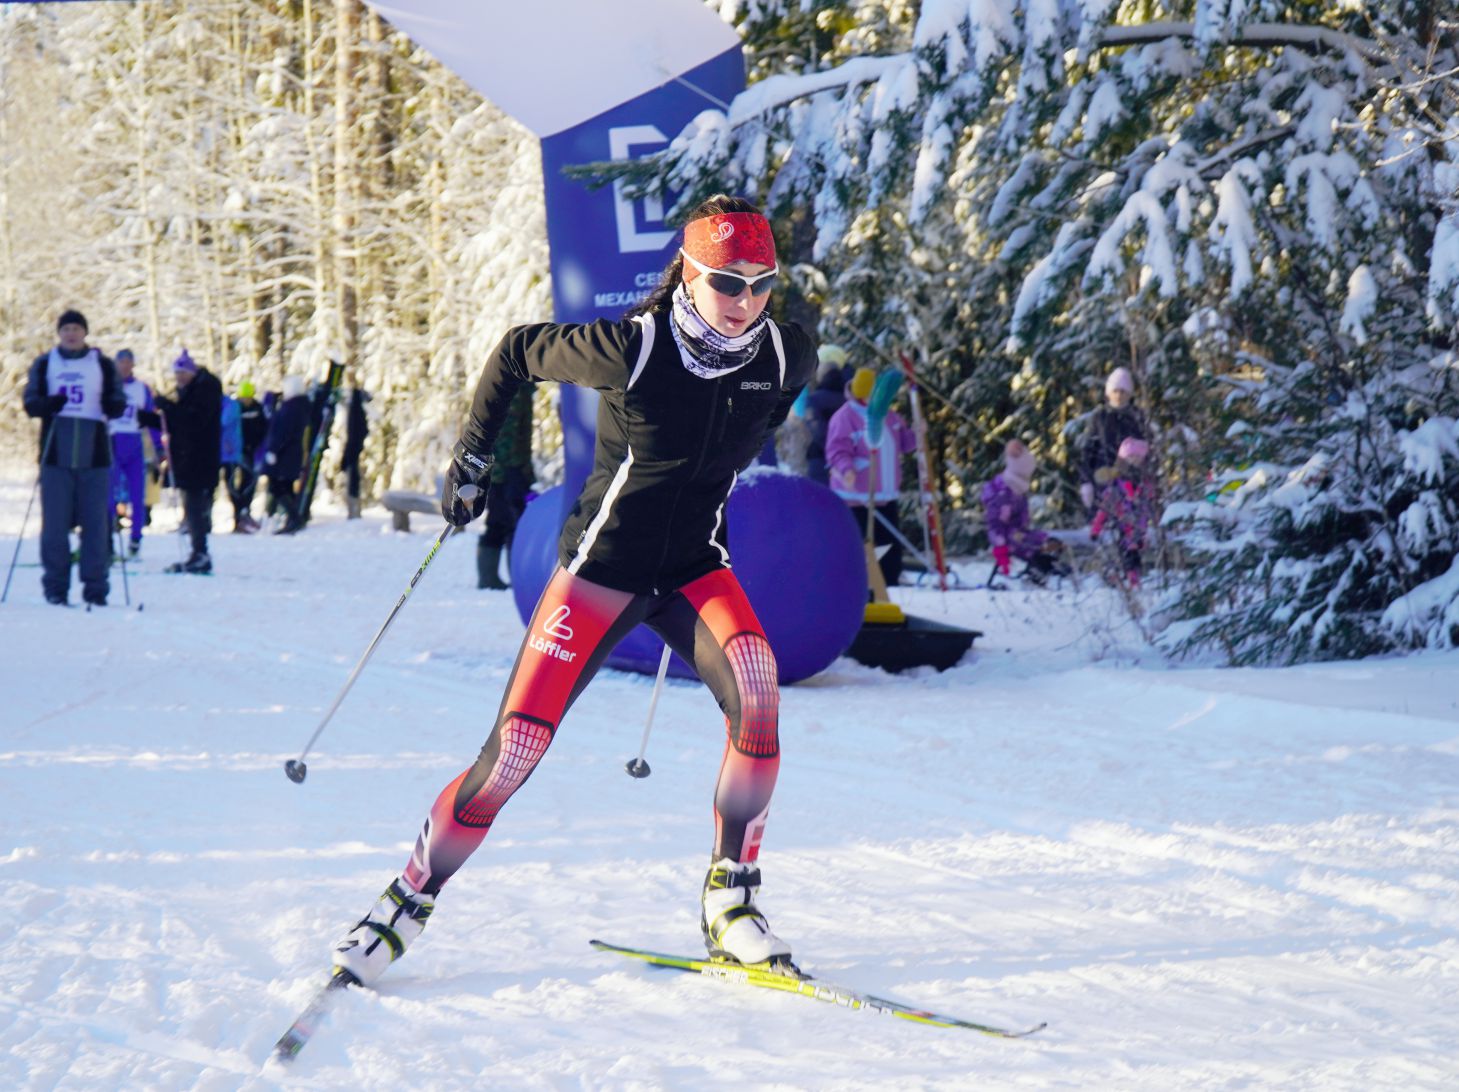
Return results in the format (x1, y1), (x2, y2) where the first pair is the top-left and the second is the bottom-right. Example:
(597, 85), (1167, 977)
(627, 0), (1459, 658)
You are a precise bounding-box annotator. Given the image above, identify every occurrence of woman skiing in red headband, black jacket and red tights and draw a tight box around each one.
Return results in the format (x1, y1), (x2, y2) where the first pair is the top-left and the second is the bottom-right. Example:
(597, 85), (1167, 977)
(325, 194), (816, 984)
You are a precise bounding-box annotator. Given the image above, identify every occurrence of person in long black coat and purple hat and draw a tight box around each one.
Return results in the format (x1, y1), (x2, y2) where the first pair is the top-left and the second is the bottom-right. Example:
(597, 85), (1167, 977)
(156, 349), (223, 575)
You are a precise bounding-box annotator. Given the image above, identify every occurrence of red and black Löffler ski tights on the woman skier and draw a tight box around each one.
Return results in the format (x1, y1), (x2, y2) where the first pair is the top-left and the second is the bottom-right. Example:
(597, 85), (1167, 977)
(406, 568), (781, 893)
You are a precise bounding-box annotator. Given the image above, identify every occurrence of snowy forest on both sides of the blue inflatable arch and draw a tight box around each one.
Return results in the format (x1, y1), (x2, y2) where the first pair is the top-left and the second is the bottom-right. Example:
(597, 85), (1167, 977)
(0, 0), (1459, 663)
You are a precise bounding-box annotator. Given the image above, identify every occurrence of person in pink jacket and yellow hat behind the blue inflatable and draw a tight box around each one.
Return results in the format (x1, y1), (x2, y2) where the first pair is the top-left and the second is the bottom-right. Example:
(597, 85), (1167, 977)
(826, 368), (916, 587)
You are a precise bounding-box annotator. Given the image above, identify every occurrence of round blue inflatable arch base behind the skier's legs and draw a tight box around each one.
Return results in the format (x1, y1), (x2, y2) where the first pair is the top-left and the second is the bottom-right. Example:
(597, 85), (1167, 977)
(511, 467), (867, 685)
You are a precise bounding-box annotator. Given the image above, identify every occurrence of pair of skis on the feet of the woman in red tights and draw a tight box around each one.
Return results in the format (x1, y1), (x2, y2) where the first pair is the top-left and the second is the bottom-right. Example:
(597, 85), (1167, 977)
(273, 940), (1048, 1063)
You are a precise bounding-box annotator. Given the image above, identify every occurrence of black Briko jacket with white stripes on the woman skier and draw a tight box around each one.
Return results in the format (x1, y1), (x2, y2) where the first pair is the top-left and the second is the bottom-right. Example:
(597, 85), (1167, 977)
(461, 312), (816, 594)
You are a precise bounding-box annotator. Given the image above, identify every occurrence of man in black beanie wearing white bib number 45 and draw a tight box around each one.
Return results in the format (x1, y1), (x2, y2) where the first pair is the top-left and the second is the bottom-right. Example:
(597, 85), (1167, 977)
(23, 311), (127, 607)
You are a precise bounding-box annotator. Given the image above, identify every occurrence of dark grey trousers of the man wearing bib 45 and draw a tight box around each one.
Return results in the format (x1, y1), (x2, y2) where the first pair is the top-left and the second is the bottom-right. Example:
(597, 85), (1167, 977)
(41, 466), (111, 599)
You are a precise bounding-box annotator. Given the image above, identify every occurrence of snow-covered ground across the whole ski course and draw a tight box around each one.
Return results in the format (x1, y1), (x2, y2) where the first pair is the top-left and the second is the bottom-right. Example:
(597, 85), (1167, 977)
(0, 477), (1459, 1091)
